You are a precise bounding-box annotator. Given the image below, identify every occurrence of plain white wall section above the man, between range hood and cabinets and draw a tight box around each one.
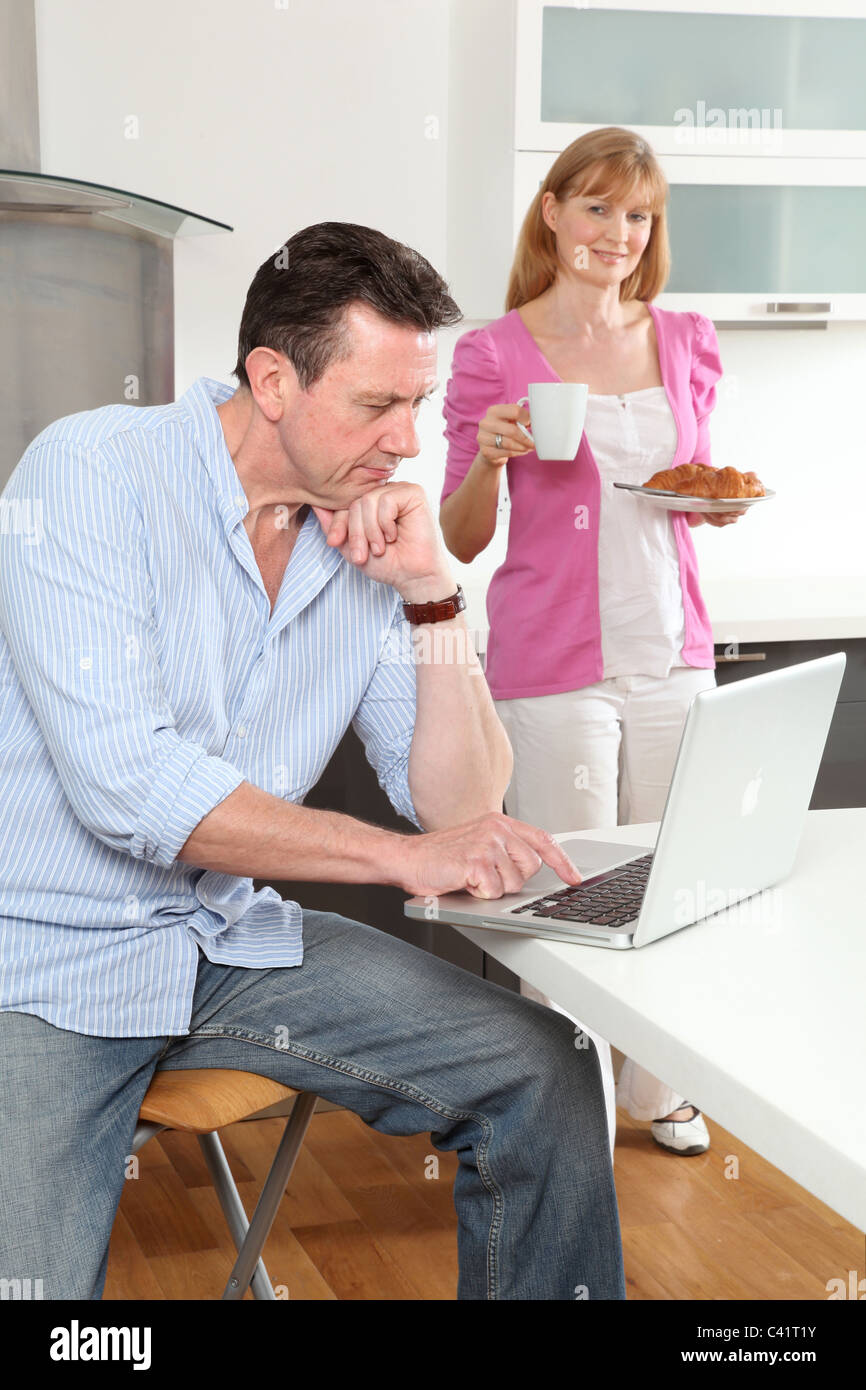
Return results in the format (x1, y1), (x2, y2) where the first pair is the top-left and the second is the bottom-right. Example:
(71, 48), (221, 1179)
(36, 0), (448, 389)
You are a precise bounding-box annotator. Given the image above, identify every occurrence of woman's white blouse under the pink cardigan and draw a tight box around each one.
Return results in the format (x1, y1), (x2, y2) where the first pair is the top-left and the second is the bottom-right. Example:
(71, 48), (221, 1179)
(585, 386), (685, 680)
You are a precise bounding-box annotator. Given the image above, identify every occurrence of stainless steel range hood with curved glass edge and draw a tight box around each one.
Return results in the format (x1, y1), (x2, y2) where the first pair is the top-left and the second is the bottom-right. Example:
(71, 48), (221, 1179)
(0, 0), (232, 488)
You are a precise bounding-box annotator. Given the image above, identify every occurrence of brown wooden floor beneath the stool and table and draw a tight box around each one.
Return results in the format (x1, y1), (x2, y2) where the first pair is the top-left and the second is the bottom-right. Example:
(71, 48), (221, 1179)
(104, 1111), (863, 1300)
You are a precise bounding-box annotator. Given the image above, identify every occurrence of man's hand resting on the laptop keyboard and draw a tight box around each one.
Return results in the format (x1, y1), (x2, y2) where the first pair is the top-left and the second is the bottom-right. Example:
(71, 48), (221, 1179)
(395, 812), (581, 898)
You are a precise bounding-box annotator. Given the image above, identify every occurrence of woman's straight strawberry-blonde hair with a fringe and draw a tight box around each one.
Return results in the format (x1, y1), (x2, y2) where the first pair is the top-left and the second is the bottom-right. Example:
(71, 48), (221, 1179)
(505, 125), (670, 313)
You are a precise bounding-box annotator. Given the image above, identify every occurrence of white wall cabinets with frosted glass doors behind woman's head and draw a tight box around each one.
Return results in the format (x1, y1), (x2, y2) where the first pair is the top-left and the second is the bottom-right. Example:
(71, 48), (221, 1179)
(448, 0), (866, 319)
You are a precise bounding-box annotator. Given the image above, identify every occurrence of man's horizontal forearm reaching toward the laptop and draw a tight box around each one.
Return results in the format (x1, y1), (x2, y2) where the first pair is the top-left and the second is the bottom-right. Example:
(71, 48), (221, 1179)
(178, 783), (407, 884)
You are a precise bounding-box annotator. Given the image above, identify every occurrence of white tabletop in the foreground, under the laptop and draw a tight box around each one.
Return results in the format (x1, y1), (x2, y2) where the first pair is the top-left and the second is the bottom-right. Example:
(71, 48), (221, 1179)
(442, 809), (866, 1230)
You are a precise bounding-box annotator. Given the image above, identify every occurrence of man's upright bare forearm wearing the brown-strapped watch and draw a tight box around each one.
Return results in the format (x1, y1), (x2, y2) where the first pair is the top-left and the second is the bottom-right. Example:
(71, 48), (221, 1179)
(403, 564), (513, 830)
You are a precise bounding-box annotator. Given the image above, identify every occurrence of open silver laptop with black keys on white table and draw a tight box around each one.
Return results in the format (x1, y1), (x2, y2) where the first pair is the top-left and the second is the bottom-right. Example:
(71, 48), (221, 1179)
(405, 652), (845, 949)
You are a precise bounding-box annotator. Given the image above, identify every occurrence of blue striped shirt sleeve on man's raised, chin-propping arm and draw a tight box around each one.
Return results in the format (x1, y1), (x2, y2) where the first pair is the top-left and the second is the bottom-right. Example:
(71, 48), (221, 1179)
(352, 602), (424, 830)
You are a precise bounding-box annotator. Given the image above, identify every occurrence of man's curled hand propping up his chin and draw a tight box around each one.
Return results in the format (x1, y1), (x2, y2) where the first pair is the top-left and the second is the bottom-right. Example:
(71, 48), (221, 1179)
(313, 482), (448, 603)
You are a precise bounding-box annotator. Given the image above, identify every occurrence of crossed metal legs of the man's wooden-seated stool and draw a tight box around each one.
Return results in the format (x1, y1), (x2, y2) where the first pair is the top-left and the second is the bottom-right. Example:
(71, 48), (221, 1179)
(199, 1091), (318, 1300)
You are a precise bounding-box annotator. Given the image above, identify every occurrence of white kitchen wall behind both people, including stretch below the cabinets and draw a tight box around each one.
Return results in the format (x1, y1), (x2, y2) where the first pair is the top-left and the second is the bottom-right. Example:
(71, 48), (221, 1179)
(36, 0), (866, 636)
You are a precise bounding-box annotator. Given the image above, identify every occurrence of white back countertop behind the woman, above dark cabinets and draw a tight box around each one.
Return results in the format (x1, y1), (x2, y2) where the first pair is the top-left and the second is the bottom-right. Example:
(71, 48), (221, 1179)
(460, 573), (866, 652)
